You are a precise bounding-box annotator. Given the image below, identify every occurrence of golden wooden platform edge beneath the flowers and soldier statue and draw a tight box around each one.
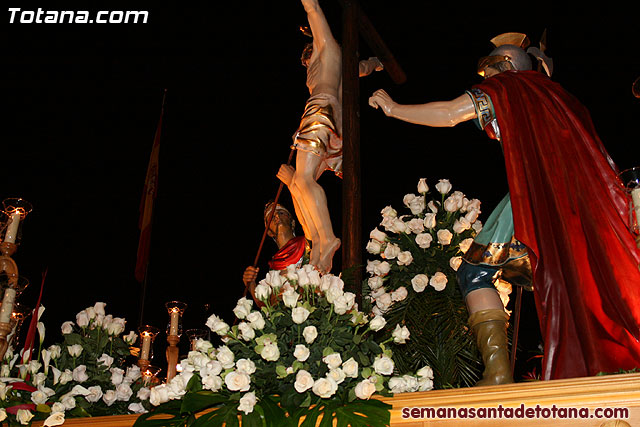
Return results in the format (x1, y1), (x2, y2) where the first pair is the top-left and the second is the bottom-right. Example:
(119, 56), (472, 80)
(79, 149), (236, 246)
(33, 374), (640, 427)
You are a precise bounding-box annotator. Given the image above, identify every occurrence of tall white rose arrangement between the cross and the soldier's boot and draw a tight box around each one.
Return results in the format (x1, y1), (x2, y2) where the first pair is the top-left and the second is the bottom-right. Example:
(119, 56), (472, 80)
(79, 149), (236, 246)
(363, 178), (498, 391)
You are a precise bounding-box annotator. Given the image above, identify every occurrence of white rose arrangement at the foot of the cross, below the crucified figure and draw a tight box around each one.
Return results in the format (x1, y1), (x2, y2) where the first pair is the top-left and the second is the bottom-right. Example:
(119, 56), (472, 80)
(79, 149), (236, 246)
(135, 265), (433, 427)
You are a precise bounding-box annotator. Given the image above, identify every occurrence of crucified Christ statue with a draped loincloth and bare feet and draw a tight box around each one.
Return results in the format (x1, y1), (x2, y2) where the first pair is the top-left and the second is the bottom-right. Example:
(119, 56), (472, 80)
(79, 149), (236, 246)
(277, 0), (383, 273)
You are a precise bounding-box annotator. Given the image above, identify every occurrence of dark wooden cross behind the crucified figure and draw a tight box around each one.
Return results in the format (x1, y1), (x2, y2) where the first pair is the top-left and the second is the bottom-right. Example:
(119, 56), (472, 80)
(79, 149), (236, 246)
(339, 0), (406, 300)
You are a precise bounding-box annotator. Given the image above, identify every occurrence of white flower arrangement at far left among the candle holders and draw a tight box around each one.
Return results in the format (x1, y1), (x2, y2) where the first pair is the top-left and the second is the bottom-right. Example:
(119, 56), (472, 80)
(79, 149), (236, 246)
(0, 302), (150, 426)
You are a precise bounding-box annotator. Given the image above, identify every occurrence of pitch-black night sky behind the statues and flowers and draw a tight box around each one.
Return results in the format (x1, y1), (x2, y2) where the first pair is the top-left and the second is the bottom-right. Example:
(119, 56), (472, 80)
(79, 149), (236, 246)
(0, 0), (640, 364)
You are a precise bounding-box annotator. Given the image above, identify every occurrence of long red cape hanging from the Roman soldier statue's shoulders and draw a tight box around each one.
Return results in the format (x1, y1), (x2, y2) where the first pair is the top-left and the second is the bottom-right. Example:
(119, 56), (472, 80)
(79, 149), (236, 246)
(477, 71), (640, 379)
